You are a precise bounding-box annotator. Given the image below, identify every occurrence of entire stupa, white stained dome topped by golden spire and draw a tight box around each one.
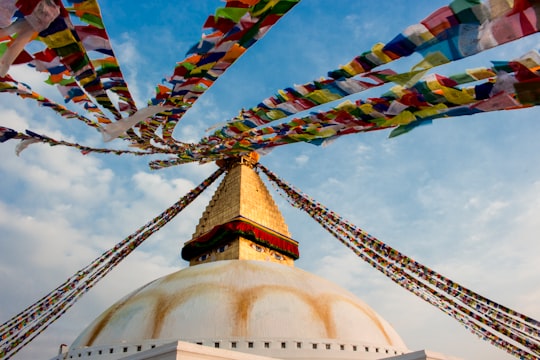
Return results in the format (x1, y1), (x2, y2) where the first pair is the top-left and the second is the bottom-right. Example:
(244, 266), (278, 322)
(49, 155), (460, 360)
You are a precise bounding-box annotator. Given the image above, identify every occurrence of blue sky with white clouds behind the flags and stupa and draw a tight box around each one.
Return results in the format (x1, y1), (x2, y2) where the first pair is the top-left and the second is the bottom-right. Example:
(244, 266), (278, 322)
(0, 0), (540, 360)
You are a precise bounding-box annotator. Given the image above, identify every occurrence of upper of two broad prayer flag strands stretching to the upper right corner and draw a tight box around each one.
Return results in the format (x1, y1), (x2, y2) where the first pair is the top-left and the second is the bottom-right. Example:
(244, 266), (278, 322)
(210, 0), (540, 139)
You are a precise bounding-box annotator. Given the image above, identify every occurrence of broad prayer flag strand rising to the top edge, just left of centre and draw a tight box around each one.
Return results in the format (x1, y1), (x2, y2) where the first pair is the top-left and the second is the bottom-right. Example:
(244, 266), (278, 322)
(137, 0), (299, 148)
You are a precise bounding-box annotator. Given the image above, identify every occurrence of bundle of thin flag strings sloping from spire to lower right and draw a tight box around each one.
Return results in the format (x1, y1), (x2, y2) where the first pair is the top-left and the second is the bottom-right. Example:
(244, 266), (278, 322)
(257, 164), (540, 360)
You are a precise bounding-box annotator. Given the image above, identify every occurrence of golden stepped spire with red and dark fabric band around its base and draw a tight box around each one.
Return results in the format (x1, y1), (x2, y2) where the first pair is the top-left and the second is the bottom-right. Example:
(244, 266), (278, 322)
(182, 153), (298, 265)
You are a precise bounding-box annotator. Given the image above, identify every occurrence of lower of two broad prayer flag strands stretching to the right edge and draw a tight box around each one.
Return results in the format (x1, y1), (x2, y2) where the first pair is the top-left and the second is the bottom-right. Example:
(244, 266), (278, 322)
(150, 51), (540, 169)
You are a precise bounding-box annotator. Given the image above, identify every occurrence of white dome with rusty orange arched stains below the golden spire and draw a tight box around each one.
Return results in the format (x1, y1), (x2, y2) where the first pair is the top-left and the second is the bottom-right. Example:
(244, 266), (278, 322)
(71, 260), (407, 359)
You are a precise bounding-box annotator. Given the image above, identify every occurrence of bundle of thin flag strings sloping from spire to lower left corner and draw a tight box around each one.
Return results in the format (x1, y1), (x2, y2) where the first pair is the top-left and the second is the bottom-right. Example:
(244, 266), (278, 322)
(0, 167), (225, 359)
